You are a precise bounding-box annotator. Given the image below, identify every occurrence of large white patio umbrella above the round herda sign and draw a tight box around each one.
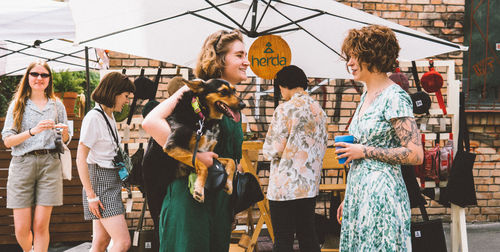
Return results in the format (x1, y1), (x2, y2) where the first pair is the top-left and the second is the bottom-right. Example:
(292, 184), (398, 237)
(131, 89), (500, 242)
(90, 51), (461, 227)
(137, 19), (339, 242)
(70, 0), (463, 78)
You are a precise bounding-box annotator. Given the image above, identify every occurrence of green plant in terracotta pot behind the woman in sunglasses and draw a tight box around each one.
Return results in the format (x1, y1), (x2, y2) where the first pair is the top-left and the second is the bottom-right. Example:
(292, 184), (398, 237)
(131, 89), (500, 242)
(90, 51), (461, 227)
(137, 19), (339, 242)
(52, 70), (85, 117)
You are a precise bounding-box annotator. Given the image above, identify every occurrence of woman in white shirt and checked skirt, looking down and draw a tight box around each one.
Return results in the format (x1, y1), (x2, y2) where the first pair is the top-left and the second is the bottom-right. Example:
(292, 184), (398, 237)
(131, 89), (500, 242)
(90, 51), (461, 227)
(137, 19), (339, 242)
(76, 72), (135, 252)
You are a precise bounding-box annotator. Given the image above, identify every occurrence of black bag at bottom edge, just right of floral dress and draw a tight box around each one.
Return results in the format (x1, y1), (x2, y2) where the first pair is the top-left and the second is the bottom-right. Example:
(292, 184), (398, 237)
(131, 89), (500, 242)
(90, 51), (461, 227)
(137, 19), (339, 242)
(411, 205), (447, 252)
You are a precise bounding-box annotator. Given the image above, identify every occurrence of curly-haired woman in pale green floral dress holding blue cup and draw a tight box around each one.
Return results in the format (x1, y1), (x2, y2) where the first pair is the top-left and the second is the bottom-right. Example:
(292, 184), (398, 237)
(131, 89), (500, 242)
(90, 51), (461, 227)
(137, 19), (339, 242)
(335, 25), (423, 251)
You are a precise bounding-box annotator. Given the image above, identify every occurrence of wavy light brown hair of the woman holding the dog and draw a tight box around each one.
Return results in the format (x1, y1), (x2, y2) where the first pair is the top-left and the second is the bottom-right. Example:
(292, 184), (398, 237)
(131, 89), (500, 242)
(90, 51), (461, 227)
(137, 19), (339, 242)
(194, 29), (243, 80)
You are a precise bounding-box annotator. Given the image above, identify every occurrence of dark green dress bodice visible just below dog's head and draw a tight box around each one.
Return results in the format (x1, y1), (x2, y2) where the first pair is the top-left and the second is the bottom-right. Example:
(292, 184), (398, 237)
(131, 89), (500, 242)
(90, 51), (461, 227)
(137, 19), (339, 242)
(214, 116), (243, 160)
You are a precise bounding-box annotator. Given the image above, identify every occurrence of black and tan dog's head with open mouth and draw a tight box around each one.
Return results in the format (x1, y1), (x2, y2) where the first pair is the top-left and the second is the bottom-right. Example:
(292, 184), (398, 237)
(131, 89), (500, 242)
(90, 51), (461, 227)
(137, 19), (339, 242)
(185, 79), (245, 122)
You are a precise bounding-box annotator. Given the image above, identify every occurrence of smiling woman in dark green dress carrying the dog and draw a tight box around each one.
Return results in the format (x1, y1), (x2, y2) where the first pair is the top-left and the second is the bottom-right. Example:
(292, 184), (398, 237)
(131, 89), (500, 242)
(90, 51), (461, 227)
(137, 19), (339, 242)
(142, 30), (250, 252)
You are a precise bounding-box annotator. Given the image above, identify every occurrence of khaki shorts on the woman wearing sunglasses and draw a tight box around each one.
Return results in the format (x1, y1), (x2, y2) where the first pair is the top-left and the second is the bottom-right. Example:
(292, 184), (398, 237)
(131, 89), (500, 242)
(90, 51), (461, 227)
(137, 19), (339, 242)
(7, 153), (63, 208)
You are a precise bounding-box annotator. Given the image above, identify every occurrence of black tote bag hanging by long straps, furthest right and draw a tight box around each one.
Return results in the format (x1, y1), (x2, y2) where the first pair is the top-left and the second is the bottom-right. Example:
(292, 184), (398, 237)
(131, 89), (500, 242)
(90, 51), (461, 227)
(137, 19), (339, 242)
(447, 93), (477, 207)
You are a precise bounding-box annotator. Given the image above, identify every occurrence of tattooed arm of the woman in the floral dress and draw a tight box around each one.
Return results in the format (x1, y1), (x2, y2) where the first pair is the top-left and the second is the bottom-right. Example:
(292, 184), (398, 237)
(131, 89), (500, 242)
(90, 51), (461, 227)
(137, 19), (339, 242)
(335, 117), (424, 165)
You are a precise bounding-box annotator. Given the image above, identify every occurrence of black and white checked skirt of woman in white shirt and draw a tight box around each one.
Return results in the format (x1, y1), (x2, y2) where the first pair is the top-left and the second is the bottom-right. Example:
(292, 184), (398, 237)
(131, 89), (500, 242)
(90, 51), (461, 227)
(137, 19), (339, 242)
(82, 164), (125, 220)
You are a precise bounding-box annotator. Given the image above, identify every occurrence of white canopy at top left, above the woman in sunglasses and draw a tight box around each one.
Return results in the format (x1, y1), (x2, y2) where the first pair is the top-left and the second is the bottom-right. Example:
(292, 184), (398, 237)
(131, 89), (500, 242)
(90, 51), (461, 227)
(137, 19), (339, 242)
(0, 0), (100, 76)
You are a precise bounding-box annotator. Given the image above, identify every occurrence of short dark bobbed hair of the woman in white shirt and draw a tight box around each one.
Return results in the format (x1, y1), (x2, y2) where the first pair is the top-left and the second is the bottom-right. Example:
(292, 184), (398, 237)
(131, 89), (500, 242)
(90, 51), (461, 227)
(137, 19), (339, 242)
(92, 72), (135, 108)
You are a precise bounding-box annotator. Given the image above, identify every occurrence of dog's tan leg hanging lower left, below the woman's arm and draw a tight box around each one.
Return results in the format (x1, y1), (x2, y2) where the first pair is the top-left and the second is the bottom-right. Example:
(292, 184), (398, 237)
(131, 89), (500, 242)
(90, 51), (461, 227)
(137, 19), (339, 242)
(164, 147), (208, 203)
